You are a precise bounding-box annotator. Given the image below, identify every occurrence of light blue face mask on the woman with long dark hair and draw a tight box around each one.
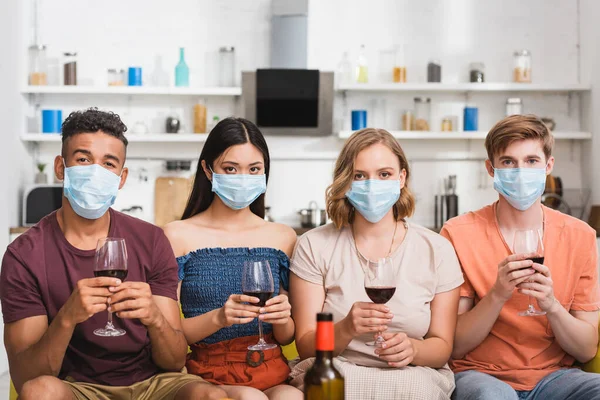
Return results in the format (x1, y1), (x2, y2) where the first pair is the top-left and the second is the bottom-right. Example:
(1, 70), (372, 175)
(211, 169), (267, 210)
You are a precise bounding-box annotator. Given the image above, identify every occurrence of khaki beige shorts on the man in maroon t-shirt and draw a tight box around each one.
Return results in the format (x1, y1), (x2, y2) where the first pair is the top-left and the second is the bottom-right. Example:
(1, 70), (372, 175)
(63, 372), (209, 400)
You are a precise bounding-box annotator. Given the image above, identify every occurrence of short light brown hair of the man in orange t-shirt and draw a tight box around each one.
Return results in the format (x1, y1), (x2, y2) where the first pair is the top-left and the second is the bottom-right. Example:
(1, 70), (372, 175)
(485, 114), (554, 165)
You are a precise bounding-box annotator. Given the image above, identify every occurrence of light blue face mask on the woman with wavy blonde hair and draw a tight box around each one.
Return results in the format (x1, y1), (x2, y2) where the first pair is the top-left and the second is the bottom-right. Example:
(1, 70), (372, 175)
(346, 179), (400, 224)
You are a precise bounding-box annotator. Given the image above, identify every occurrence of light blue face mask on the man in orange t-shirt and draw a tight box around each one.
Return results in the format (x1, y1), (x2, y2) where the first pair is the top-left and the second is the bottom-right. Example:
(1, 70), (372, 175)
(494, 168), (546, 211)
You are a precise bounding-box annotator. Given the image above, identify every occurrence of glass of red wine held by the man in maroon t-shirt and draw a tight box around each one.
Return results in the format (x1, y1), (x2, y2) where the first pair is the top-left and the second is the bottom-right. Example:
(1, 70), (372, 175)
(94, 238), (127, 337)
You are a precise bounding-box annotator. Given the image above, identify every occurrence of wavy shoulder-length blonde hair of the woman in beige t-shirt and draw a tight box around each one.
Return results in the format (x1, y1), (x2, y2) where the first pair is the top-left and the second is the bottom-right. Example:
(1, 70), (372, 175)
(326, 128), (415, 229)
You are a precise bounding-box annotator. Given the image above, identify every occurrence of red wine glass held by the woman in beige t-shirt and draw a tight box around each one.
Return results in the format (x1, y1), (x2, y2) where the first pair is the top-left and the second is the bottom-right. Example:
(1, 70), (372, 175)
(365, 257), (396, 347)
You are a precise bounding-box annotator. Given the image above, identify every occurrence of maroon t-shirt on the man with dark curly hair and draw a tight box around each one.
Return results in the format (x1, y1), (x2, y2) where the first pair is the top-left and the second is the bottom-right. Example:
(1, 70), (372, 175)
(0, 209), (177, 386)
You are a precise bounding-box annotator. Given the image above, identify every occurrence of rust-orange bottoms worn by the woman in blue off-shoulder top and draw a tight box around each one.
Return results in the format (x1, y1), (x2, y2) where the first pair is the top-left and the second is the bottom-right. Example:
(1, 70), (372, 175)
(186, 334), (290, 390)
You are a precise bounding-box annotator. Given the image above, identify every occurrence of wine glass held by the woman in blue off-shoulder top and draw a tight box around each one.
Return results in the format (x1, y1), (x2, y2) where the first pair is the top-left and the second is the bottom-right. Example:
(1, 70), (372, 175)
(242, 260), (277, 350)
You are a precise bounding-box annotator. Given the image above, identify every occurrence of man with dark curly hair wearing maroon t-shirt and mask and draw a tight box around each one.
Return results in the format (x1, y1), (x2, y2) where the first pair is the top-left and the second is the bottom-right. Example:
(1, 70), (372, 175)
(0, 108), (226, 400)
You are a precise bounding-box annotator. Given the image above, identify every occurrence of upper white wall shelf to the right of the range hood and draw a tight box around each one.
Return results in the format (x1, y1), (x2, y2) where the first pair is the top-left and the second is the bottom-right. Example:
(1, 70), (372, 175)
(336, 82), (591, 93)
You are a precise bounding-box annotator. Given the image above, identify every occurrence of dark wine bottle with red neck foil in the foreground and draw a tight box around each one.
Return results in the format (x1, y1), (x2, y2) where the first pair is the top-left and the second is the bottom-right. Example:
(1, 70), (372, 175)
(304, 313), (344, 400)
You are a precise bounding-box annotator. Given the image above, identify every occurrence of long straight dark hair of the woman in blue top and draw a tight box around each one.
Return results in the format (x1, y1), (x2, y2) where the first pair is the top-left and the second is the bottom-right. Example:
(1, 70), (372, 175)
(181, 117), (271, 219)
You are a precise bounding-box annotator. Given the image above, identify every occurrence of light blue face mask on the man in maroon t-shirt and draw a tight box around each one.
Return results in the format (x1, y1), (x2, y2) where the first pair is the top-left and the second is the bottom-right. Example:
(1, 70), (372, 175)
(63, 164), (121, 219)
